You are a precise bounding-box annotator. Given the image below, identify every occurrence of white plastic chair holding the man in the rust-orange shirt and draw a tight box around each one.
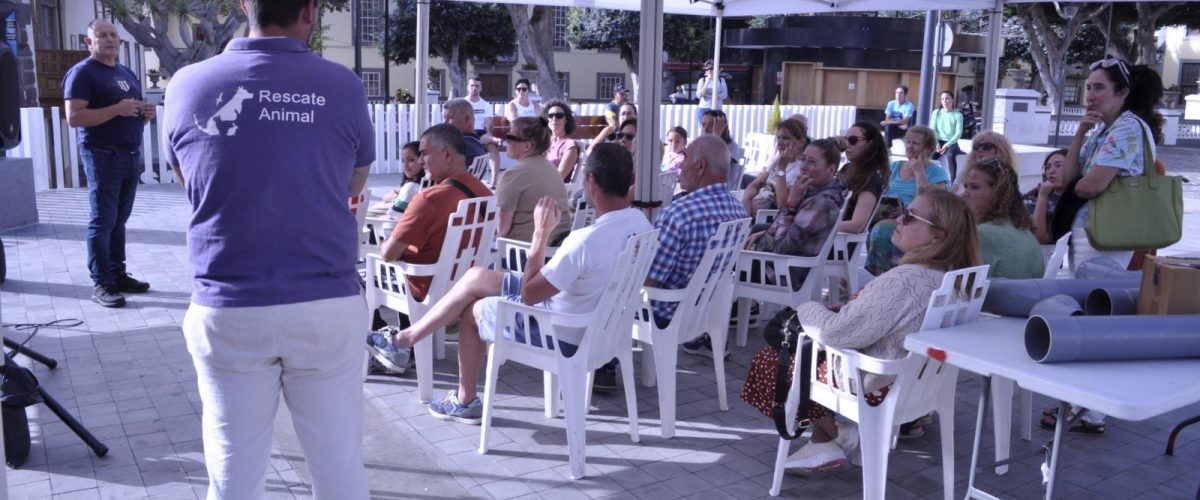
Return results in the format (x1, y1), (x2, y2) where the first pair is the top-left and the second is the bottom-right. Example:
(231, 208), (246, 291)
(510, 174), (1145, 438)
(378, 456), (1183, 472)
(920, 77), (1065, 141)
(366, 197), (498, 403)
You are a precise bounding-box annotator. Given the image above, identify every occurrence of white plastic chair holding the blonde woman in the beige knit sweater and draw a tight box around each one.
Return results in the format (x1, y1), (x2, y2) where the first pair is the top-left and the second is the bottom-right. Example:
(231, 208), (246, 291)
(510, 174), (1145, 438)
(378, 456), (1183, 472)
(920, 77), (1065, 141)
(770, 265), (989, 500)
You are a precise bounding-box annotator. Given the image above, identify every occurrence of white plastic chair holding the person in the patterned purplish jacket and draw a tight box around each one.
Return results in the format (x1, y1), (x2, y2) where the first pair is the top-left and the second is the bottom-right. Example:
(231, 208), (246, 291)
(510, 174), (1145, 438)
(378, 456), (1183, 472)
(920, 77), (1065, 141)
(733, 198), (850, 348)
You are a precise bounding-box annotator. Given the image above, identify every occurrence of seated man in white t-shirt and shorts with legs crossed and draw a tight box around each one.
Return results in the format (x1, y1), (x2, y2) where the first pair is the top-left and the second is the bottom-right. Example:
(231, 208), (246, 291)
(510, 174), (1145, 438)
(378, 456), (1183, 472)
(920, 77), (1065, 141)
(392, 144), (653, 424)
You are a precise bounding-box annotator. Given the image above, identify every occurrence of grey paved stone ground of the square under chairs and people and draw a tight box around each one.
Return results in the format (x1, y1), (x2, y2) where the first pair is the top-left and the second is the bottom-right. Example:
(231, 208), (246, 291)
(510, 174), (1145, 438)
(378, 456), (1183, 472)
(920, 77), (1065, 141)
(0, 167), (1200, 500)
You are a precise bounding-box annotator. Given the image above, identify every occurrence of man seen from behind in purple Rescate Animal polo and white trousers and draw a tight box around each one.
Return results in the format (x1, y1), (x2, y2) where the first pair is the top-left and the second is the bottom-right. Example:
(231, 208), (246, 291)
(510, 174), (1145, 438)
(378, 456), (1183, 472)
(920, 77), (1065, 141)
(166, 0), (374, 499)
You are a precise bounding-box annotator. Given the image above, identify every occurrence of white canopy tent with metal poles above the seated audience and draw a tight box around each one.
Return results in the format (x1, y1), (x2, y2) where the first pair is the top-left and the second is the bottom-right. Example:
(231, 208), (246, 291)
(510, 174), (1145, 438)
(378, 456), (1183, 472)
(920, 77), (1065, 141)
(416, 0), (1123, 208)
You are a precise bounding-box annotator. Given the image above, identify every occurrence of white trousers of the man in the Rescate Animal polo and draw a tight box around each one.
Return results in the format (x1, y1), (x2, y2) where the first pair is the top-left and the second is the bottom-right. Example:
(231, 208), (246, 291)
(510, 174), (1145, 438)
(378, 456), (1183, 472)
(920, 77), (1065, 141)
(184, 295), (368, 500)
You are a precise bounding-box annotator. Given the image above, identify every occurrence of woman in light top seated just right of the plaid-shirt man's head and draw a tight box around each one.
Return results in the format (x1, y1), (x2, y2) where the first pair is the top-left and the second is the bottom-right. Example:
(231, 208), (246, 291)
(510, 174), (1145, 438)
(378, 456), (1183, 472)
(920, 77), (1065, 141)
(742, 119), (809, 215)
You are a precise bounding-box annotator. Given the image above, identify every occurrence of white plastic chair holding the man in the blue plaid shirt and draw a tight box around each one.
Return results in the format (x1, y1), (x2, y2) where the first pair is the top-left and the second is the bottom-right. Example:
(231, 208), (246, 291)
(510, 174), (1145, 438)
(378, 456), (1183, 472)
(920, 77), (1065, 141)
(634, 218), (750, 438)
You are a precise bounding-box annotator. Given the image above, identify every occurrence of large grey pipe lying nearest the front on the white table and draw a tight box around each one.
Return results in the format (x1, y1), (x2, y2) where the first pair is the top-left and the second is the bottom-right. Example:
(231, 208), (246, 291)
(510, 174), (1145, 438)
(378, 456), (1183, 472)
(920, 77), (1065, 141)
(1027, 314), (1200, 363)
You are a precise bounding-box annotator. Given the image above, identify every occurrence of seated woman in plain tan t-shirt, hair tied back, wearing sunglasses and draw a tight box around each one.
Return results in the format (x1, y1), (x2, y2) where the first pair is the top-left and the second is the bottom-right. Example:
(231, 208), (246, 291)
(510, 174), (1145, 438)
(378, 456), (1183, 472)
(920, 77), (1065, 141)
(496, 116), (571, 243)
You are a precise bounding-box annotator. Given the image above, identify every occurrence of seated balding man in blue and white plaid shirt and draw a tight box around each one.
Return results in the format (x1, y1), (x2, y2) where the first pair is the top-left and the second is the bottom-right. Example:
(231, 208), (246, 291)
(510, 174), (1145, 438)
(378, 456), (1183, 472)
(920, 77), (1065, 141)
(593, 135), (749, 390)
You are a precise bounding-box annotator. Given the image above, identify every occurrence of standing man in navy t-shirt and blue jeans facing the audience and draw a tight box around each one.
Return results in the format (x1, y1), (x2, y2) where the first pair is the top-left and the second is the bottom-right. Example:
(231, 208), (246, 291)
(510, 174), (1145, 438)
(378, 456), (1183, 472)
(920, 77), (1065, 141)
(62, 19), (155, 307)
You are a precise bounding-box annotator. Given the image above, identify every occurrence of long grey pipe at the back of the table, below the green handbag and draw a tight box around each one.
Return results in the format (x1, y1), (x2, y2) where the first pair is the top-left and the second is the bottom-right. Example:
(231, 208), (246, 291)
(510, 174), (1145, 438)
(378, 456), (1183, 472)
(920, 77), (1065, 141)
(983, 278), (1141, 318)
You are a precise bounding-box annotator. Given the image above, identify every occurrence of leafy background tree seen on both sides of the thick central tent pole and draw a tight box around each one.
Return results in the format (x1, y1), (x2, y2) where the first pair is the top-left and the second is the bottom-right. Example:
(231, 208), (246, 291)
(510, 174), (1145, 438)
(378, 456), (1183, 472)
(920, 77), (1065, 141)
(566, 8), (713, 95)
